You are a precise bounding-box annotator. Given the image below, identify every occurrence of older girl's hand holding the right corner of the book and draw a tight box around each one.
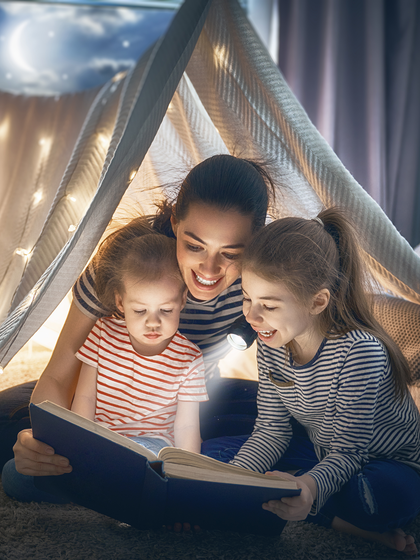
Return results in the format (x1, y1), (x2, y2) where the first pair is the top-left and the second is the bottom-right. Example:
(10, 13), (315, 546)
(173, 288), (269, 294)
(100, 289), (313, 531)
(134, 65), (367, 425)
(262, 471), (316, 521)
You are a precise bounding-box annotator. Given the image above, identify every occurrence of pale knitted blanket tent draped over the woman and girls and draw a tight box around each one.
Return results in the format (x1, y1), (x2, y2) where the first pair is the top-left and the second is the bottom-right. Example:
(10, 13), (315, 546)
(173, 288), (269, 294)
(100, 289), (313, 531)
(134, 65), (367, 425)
(0, 0), (420, 372)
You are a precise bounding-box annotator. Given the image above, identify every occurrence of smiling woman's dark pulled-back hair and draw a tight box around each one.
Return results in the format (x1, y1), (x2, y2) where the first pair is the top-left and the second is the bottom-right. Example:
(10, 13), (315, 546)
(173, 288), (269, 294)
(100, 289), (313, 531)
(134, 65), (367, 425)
(154, 154), (275, 235)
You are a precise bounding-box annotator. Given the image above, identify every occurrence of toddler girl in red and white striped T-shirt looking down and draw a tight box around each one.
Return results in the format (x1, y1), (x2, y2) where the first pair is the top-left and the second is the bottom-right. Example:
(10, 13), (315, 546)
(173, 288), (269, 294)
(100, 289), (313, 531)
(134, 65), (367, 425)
(71, 218), (207, 454)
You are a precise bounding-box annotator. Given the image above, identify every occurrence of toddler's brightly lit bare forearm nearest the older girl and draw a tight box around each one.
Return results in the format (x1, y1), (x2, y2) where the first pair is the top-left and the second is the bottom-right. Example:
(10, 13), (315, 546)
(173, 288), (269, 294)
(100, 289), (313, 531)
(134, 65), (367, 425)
(174, 401), (201, 453)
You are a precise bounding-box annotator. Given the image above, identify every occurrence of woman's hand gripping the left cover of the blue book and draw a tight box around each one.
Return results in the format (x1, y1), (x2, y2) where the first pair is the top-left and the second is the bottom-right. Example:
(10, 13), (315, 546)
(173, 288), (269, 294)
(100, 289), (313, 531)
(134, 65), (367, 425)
(13, 430), (72, 476)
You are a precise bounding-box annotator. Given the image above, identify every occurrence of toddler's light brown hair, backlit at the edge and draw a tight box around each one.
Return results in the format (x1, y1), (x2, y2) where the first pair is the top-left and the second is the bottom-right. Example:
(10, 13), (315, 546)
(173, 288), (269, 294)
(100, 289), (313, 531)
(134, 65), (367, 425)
(93, 217), (186, 317)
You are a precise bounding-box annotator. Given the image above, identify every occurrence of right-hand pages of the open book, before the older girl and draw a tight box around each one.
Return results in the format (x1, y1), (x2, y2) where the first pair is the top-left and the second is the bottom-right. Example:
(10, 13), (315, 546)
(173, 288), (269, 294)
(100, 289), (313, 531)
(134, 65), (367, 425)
(164, 463), (297, 489)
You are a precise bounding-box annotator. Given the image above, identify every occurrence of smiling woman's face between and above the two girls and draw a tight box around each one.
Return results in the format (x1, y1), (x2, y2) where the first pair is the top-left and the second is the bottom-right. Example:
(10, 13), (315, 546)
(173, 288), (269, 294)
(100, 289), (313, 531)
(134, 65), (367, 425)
(171, 203), (252, 301)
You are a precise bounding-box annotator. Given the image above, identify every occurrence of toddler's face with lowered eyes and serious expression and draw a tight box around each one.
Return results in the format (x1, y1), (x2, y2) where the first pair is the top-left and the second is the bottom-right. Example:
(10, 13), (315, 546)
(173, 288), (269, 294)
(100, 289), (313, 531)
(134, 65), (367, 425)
(115, 276), (187, 356)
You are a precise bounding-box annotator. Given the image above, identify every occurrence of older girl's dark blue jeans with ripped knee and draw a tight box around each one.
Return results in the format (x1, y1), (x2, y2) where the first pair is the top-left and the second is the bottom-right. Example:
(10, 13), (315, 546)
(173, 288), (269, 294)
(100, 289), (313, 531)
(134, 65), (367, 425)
(201, 434), (420, 533)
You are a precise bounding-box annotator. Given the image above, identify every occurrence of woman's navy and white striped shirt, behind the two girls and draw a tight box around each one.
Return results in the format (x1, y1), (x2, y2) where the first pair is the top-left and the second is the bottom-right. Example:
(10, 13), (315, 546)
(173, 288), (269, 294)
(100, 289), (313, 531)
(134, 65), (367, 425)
(73, 262), (243, 381)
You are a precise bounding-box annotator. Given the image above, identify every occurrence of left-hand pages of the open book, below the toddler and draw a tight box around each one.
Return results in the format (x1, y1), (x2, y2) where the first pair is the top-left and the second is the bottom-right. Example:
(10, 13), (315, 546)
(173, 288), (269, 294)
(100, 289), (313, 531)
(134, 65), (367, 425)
(34, 401), (157, 461)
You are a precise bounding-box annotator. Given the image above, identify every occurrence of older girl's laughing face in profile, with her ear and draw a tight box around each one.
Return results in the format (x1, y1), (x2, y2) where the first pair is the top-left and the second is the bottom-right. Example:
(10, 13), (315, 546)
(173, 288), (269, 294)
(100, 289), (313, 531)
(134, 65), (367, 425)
(242, 270), (329, 363)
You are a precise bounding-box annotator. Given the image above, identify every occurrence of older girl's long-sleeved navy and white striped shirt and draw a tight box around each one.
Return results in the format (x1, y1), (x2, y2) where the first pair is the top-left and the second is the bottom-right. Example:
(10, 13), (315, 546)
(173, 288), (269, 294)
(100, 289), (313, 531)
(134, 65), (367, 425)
(232, 330), (420, 514)
